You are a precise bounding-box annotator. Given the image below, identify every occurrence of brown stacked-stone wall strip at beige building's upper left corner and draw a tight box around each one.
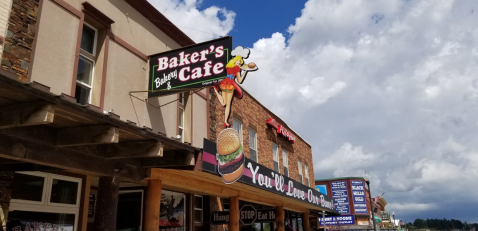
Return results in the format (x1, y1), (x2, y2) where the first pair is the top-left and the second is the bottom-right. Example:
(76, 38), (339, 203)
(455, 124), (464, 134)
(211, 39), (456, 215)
(0, 0), (40, 82)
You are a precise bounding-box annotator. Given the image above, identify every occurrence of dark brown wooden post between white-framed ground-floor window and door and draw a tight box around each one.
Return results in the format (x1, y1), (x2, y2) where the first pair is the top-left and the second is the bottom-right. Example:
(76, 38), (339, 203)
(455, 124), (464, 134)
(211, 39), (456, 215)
(94, 176), (119, 231)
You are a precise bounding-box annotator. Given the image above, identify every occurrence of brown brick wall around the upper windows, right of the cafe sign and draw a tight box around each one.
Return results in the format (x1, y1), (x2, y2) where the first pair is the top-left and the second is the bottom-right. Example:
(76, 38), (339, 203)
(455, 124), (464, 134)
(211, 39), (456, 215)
(209, 88), (314, 187)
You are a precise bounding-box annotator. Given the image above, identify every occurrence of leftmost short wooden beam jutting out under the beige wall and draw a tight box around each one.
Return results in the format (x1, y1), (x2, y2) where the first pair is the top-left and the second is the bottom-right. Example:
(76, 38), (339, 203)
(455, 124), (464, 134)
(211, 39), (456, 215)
(0, 102), (55, 129)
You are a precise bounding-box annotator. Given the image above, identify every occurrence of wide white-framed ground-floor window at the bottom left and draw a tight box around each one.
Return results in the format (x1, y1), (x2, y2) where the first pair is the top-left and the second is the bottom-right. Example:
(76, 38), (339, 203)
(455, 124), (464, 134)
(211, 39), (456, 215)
(7, 172), (82, 230)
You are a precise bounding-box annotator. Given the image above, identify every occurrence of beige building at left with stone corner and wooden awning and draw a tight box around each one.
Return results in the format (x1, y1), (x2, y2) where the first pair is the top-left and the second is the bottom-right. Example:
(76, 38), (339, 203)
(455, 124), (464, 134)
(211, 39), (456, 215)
(0, 0), (208, 230)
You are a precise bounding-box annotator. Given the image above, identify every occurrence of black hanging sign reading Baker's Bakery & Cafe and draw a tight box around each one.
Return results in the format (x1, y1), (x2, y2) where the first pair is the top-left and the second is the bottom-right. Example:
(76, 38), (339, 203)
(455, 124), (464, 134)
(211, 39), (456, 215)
(148, 36), (232, 97)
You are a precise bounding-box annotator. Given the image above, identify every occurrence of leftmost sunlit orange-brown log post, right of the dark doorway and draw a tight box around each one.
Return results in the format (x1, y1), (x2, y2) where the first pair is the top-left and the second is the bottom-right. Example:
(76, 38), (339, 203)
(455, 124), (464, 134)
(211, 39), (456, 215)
(144, 179), (162, 231)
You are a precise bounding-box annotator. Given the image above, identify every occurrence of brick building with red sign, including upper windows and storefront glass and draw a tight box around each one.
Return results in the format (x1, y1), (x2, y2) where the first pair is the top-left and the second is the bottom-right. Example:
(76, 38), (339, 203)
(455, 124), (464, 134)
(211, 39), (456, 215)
(205, 89), (319, 230)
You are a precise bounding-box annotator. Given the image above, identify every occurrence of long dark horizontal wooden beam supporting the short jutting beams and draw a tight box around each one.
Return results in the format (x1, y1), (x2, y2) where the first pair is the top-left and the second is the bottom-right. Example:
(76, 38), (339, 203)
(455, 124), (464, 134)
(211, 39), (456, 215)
(0, 132), (145, 182)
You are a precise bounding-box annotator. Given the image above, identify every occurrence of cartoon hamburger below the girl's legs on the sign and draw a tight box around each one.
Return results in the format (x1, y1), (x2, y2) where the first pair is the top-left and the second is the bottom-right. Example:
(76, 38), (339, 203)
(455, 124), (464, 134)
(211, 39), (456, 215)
(216, 128), (245, 184)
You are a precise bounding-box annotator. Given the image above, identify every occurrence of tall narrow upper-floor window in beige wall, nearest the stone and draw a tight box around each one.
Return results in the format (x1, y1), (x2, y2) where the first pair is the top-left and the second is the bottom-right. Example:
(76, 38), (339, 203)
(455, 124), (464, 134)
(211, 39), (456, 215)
(75, 23), (98, 104)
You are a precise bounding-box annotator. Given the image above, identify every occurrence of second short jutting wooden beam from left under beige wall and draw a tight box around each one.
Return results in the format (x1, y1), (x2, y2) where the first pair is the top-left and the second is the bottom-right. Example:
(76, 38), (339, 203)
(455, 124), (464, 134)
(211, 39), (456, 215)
(56, 125), (119, 147)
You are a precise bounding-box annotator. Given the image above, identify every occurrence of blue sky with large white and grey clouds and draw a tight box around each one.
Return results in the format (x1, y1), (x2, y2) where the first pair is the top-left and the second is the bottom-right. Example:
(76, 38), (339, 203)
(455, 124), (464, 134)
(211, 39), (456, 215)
(149, 0), (478, 223)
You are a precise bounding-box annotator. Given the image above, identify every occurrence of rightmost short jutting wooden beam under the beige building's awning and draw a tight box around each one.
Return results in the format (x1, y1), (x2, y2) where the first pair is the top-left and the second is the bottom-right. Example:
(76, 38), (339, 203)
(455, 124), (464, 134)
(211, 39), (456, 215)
(143, 151), (196, 168)
